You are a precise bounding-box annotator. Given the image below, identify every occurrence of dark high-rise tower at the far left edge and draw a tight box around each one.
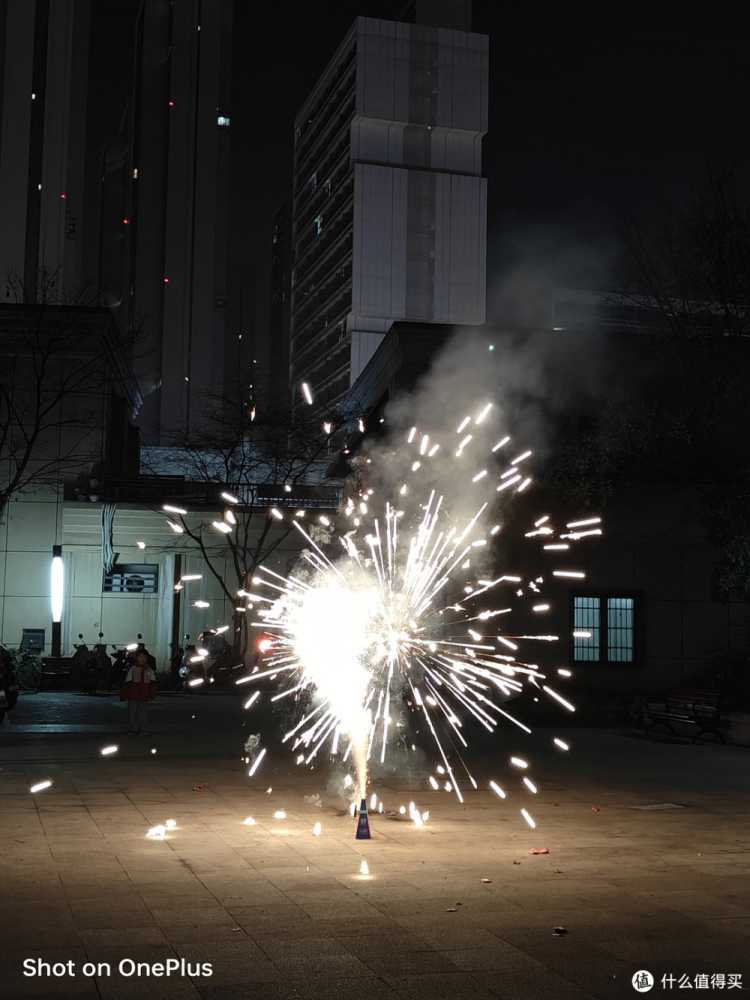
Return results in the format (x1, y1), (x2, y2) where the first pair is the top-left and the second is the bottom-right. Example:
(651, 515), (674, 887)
(0, 0), (90, 303)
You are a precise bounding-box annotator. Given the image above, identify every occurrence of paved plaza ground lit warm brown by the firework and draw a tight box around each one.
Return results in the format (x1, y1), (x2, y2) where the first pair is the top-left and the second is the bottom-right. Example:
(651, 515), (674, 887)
(0, 693), (750, 1000)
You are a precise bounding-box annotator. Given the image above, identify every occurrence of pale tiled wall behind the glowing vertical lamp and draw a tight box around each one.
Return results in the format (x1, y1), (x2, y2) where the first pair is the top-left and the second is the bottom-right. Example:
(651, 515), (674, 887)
(0, 490), (312, 667)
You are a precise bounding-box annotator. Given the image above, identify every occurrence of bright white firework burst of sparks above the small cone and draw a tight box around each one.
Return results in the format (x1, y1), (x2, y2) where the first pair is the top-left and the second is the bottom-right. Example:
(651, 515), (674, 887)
(237, 396), (602, 827)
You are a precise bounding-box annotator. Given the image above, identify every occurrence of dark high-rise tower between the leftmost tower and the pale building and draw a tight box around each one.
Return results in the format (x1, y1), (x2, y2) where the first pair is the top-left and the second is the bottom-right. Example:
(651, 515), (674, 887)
(100, 0), (237, 443)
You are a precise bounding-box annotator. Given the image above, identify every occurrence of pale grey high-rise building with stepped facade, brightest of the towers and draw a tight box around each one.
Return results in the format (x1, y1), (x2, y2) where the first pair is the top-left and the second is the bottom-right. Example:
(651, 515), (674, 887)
(290, 9), (488, 414)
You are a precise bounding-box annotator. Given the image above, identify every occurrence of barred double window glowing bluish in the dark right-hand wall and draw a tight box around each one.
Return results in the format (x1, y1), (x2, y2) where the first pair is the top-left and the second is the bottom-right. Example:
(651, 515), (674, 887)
(573, 594), (636, 663)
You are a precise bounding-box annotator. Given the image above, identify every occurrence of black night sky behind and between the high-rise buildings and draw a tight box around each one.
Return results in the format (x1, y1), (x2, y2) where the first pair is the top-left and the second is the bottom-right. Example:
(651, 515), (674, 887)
(86, 0), (750, 342)
